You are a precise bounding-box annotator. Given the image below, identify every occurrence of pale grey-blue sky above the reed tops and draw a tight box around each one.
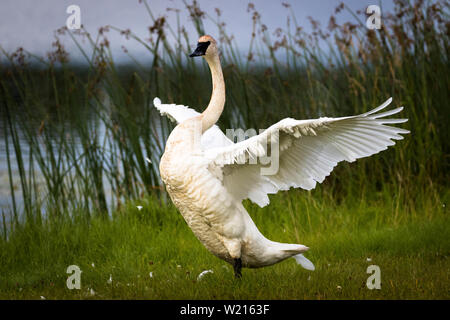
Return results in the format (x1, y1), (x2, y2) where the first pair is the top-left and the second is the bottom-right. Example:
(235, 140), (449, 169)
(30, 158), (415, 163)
(0, 0), (393, 61)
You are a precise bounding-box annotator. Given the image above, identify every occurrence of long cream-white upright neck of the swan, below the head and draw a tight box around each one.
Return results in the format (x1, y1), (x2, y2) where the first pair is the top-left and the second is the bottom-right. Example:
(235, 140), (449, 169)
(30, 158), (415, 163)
(202, 54), (225, 133)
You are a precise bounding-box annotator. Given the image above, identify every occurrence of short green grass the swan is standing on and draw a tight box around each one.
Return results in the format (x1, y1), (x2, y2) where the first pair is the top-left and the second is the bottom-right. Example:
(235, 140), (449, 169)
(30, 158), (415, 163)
(0, 191), (450, 299)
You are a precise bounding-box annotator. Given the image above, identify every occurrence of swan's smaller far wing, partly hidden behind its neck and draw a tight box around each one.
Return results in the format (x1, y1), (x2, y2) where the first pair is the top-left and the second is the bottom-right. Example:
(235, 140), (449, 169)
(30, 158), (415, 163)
(153, 98), (233, 150)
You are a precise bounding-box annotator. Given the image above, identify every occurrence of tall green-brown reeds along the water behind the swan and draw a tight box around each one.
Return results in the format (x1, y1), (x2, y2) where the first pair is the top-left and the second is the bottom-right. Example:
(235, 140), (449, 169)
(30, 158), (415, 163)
(0, 0), (450, 228)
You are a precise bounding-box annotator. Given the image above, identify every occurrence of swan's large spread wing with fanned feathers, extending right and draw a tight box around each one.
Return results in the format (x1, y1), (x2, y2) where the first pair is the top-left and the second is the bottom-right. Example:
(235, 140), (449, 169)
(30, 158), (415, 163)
(205, 98), (409, 207)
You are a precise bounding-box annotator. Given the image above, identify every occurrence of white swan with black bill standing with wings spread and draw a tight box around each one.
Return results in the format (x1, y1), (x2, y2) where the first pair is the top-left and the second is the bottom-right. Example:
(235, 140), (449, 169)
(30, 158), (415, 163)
(153, 35), (409, 278)
